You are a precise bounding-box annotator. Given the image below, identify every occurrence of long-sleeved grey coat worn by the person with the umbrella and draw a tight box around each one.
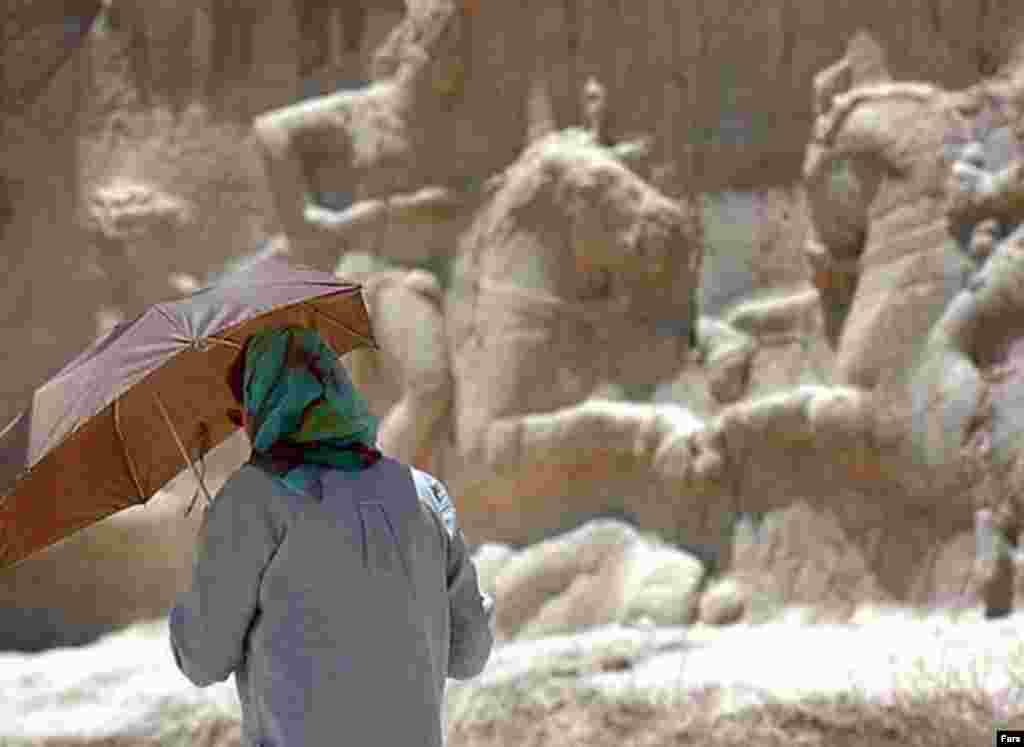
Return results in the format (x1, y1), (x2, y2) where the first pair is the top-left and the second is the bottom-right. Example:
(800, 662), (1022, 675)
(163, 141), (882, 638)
(169, 457), (494, 747)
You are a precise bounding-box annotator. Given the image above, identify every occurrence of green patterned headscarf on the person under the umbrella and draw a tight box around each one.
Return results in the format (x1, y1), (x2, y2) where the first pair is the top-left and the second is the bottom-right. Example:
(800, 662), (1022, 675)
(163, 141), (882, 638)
(242, 327), (381, 498)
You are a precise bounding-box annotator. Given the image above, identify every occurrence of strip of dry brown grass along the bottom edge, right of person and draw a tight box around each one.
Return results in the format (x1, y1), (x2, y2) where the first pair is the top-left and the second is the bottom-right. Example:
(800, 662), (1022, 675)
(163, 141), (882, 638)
(449, 690), (1024, 747)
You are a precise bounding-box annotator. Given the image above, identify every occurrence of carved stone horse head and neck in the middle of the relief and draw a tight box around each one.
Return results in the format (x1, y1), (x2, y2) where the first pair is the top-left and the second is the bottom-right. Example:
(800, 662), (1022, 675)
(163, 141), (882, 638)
(452, 129), (701, 430)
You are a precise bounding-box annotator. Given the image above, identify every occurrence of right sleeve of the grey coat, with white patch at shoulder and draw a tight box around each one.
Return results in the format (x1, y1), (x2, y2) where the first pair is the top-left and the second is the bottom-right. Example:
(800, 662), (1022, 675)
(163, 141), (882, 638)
(413, 469), (495, 679)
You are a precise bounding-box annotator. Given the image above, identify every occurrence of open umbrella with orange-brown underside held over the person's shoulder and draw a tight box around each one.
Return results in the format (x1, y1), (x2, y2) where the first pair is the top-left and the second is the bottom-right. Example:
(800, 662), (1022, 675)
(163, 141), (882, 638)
(0, 256), (377, 569)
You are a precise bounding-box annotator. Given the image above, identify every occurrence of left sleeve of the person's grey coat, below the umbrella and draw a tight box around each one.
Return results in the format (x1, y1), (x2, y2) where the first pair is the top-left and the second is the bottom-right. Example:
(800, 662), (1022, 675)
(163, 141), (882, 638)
(168, 467), (284, 688)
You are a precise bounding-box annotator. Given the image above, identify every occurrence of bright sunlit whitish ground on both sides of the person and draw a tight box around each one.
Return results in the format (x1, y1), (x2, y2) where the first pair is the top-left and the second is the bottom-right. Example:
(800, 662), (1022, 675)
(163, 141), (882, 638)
(0, 612), (1024, 742)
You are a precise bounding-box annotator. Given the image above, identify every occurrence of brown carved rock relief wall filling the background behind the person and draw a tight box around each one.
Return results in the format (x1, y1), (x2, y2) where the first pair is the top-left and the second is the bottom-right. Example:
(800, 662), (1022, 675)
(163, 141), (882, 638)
(6, 0), (1024, 655)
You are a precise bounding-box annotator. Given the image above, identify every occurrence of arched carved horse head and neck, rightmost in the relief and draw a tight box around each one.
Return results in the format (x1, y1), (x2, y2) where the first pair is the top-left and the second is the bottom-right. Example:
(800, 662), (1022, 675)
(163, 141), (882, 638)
(804, 75), (959, 390)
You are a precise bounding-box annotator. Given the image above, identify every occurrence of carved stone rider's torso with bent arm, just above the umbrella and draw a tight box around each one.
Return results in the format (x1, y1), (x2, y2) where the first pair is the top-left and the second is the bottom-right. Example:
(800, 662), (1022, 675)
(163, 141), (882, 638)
(254, 3), (466, 268)
